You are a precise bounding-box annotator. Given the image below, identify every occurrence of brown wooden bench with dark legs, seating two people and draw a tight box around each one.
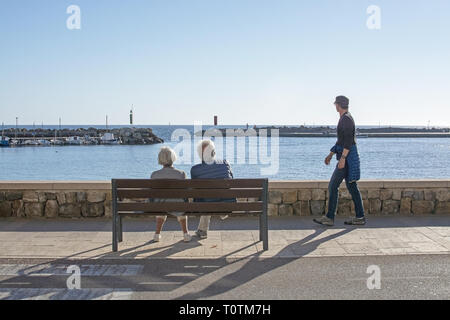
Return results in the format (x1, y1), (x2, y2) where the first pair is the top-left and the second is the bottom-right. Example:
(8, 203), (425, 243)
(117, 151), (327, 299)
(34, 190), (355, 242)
(112, 179), (269, 252)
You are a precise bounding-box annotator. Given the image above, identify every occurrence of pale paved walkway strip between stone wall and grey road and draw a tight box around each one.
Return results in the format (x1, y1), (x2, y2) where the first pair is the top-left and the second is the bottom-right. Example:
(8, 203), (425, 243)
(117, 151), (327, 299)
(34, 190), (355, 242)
(0, 216), (450, 259)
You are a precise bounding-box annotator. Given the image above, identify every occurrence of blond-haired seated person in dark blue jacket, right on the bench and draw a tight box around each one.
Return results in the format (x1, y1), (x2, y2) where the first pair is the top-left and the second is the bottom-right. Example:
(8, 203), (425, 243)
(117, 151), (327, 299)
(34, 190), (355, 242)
(191, 140), (236, 239)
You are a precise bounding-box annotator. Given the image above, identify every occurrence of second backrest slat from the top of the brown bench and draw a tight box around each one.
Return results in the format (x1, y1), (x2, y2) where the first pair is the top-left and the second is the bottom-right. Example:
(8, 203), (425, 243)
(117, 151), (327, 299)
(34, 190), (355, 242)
(117, 189), (263, 199)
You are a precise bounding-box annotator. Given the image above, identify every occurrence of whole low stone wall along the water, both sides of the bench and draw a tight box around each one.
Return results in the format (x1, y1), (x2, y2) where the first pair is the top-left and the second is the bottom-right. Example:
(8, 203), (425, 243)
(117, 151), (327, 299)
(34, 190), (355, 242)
(0, 180), (450, 218)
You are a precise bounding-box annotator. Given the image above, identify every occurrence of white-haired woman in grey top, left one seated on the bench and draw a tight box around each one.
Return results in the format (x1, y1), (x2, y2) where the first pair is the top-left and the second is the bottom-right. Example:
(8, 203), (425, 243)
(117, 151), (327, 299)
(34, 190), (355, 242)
(151, 147), (191, 242)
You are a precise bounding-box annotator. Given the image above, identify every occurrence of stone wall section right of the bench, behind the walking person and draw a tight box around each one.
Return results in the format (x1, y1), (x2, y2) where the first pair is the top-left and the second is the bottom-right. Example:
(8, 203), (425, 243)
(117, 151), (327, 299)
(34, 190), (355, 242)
(269, 180), (450, 216)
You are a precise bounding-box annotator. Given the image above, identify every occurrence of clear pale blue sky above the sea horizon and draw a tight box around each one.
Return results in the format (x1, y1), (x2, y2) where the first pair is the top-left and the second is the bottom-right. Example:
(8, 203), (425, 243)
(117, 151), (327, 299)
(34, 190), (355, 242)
(0, 0), (450, 126)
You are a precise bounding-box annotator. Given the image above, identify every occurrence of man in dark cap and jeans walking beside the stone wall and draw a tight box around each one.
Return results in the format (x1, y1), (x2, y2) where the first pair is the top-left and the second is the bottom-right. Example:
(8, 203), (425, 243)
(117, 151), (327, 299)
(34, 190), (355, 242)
(314, 96), (366, 226)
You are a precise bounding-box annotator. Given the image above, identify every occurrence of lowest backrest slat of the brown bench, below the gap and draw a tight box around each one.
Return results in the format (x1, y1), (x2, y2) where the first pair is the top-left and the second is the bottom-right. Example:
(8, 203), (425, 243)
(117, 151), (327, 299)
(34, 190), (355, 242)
(117, 201), (263, 213)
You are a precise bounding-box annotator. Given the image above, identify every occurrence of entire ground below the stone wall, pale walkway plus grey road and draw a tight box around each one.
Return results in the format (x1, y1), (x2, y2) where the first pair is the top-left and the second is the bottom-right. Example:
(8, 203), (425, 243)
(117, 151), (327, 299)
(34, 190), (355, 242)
(0, 216), (450, 300)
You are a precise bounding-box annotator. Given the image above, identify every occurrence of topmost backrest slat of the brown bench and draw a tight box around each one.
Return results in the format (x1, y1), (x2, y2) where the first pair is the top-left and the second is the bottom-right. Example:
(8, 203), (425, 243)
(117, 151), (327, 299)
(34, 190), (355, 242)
(115, 179), (265, 189)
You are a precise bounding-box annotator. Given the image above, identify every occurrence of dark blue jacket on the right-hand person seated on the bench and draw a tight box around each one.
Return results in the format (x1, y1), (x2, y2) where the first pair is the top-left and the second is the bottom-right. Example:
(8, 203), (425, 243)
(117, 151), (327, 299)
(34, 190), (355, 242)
(191, 160), (236, 202)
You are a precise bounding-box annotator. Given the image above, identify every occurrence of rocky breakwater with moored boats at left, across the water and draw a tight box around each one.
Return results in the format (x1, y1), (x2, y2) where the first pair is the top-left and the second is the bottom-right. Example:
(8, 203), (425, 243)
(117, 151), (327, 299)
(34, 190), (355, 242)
(1, 128), (164, 146)
